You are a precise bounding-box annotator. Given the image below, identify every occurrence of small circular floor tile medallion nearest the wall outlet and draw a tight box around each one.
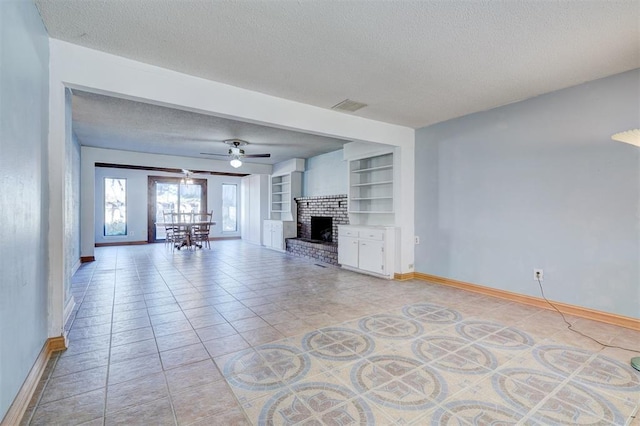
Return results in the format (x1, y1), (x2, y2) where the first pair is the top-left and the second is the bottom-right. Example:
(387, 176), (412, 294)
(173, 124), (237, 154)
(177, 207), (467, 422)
(456, 320), (534, 349)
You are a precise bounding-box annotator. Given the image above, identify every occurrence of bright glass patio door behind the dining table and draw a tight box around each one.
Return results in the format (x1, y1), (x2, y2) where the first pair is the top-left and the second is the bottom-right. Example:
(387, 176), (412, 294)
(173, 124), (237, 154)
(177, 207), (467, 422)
(147, 176), (207, 243)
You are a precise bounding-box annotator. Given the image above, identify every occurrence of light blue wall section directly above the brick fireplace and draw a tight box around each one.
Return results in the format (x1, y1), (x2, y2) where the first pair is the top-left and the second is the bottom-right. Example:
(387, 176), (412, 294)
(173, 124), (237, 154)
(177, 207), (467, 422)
(302, 150), (348, 197)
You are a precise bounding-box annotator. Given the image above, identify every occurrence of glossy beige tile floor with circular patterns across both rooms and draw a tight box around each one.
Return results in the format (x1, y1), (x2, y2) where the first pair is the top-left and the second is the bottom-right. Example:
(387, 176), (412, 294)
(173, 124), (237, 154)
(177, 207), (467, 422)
(23, 241), (640, 425)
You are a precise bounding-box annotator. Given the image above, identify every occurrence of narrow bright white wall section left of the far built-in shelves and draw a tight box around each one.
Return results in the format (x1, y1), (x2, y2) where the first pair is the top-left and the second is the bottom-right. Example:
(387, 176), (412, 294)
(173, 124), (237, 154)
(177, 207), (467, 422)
(240, 175), (269, 244)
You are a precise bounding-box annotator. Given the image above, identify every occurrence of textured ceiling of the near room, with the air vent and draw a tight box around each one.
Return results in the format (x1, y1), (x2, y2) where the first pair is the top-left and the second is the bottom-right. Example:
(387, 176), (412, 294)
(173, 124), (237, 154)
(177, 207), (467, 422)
(36, 0), (640, 128)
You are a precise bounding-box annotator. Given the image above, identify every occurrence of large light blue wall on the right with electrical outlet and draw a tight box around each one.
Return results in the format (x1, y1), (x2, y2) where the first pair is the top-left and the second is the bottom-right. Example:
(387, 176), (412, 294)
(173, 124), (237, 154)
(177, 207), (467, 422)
(415, 70), (640, 318)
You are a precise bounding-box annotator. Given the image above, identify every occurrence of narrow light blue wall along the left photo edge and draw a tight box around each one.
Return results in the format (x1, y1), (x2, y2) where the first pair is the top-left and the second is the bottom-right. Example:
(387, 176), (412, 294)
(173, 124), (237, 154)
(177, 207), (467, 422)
(0, 0), (49, 419)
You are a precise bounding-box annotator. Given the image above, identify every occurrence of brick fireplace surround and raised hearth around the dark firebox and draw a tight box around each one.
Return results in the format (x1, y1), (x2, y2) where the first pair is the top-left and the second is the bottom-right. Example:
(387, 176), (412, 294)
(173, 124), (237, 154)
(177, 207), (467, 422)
(287, 195), (349, 265)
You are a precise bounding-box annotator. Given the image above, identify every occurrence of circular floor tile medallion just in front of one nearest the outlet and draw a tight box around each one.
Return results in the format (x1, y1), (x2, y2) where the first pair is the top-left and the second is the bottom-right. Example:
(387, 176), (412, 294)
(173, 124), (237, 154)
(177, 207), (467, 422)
(411, 336), (498, 374)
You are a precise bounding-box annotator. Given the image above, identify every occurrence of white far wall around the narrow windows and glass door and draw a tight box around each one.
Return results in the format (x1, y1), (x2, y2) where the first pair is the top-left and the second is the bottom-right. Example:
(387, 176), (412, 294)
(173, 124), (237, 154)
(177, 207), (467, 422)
(93, 167), (240, 243)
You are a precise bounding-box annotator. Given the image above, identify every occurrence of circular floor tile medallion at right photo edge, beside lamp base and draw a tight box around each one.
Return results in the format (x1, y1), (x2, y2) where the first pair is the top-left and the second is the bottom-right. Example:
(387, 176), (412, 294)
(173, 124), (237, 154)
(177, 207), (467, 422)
(533, 345), (640, 392)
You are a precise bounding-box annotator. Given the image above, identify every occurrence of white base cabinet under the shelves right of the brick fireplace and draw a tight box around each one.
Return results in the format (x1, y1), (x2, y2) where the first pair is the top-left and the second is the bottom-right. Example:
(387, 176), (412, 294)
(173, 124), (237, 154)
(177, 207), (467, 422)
(338, 225), (395, 278)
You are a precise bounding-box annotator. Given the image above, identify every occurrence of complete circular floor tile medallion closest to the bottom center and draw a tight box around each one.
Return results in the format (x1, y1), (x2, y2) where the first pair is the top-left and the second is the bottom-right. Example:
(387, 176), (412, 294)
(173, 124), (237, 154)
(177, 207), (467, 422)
(351, 355), (447, 410)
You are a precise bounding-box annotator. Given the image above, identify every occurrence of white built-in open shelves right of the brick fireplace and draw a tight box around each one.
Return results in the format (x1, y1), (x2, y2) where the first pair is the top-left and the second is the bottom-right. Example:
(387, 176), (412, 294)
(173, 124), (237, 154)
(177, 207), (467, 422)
(349, 153), (394, 214)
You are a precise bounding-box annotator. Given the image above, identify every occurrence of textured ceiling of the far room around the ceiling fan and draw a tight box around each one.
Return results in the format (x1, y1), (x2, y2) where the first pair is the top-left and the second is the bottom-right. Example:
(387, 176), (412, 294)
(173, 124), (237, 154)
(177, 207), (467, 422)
(72, 90), (349, 164)
